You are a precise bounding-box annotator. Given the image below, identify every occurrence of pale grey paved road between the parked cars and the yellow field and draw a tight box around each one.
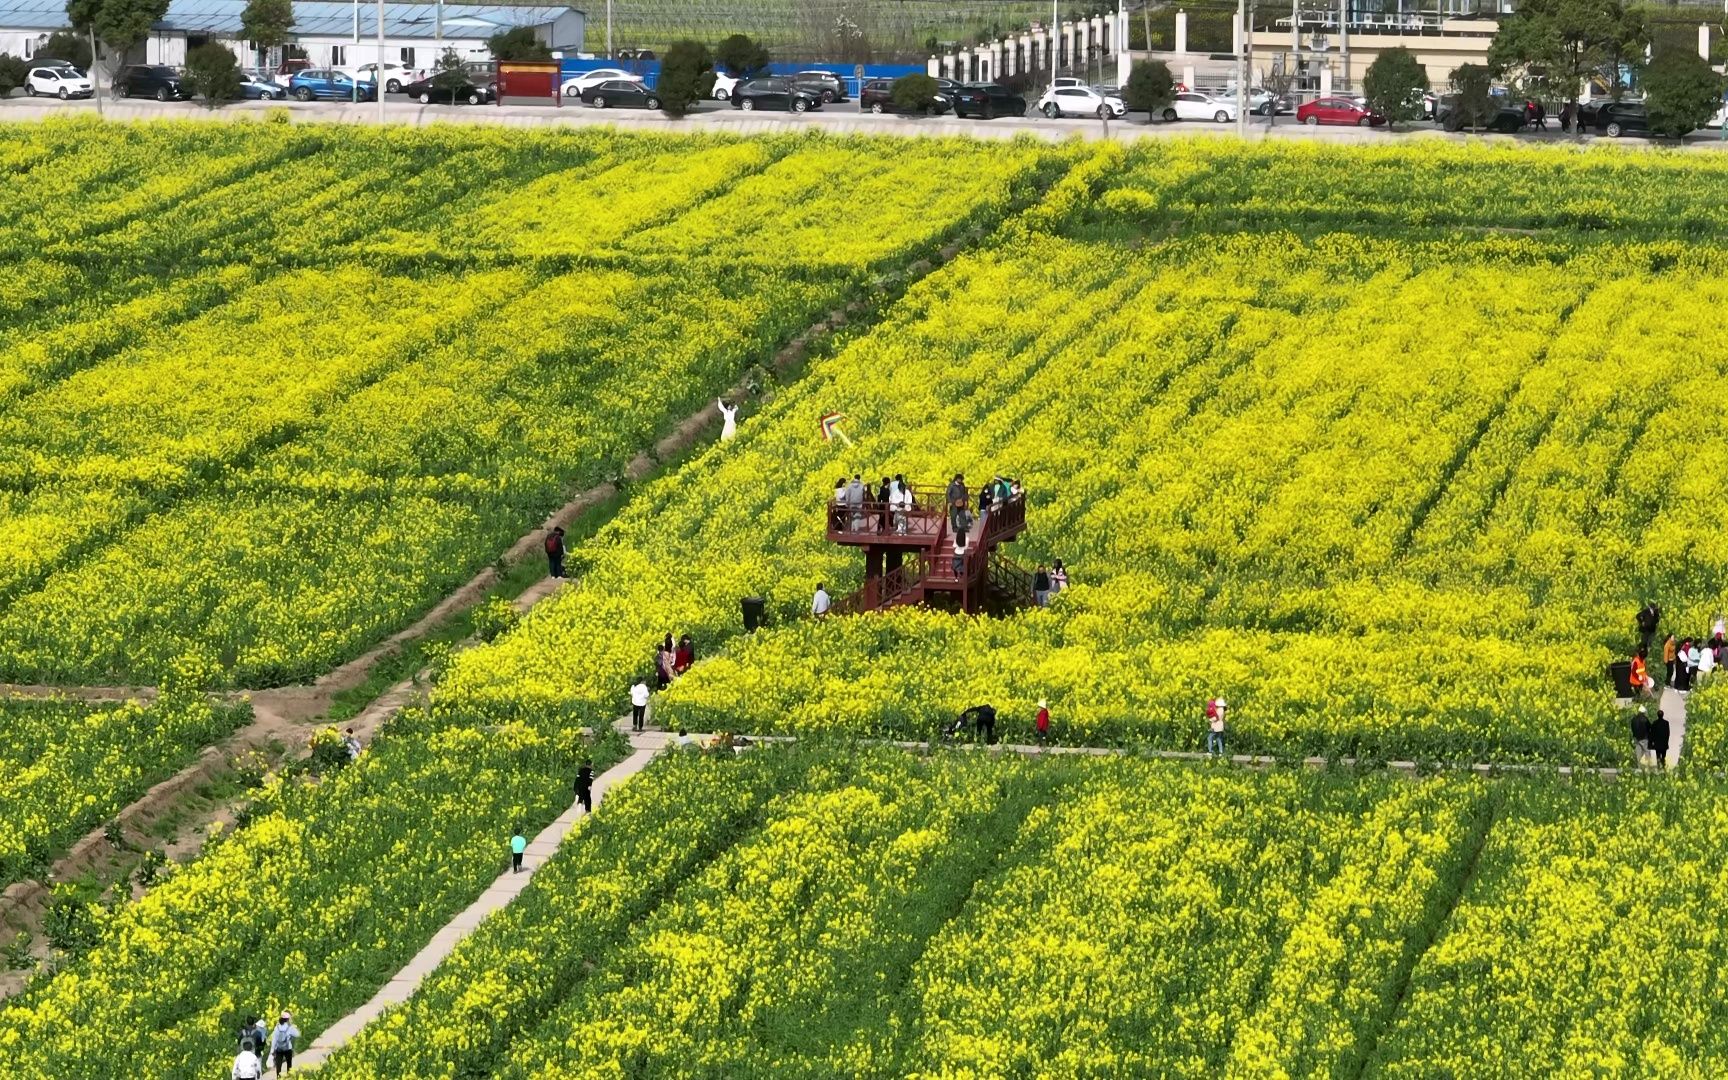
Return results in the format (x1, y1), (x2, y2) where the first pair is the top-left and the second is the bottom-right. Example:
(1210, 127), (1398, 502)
(0, 97), (1725, 149)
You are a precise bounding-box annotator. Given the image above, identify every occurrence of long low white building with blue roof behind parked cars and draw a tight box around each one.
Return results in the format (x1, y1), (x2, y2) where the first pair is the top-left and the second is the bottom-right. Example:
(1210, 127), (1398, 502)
(0, 0), (586, 71)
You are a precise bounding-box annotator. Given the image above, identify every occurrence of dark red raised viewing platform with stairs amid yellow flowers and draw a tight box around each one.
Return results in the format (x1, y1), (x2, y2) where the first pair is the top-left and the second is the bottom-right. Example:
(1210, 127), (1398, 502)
(828, 486), (1032, 613)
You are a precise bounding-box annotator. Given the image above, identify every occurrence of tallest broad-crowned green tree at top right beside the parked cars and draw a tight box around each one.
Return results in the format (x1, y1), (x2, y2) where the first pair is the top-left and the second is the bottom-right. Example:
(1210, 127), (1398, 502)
(1488, 0), (1636, 109)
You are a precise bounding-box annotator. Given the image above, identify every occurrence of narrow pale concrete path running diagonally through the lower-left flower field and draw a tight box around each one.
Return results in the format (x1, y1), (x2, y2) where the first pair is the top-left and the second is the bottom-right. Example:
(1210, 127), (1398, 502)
(294, 731), (672, 1068)
